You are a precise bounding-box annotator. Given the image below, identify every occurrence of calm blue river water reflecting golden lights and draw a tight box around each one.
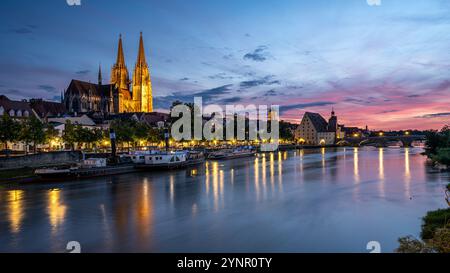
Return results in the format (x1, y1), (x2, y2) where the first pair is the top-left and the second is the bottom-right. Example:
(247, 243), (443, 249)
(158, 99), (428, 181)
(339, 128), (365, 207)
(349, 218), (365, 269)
(0, 148), (449, 252)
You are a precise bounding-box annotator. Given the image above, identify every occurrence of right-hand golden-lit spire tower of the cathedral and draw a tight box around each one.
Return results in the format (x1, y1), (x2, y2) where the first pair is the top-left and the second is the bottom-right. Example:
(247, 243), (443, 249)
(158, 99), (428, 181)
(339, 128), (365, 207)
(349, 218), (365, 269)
(133, 32), (153, 112)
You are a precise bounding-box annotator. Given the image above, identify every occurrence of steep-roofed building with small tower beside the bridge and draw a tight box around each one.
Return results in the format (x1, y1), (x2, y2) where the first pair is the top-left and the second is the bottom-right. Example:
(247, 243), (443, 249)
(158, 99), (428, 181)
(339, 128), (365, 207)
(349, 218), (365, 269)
(295, 110), (342, 145)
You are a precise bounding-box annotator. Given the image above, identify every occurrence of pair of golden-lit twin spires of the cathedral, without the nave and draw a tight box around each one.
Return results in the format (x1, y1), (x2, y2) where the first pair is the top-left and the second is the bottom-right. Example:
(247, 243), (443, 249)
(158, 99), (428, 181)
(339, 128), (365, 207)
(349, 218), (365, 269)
(111, 32), (153, 112)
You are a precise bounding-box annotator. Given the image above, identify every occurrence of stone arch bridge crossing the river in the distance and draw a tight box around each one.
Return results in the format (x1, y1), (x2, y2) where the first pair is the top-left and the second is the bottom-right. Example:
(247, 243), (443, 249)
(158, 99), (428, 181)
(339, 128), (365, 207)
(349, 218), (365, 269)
(337, 135), (425, 147)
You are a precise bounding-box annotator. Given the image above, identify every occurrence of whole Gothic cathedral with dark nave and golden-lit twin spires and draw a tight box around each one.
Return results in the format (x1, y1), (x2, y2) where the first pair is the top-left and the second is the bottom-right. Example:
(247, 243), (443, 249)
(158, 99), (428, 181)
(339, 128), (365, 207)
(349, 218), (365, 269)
(61, 32), (153, 113)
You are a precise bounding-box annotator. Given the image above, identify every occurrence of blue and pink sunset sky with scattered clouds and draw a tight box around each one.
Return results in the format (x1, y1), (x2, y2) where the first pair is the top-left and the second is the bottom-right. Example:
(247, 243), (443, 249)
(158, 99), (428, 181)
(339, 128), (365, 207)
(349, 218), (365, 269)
(0, 0), (450, 130)
